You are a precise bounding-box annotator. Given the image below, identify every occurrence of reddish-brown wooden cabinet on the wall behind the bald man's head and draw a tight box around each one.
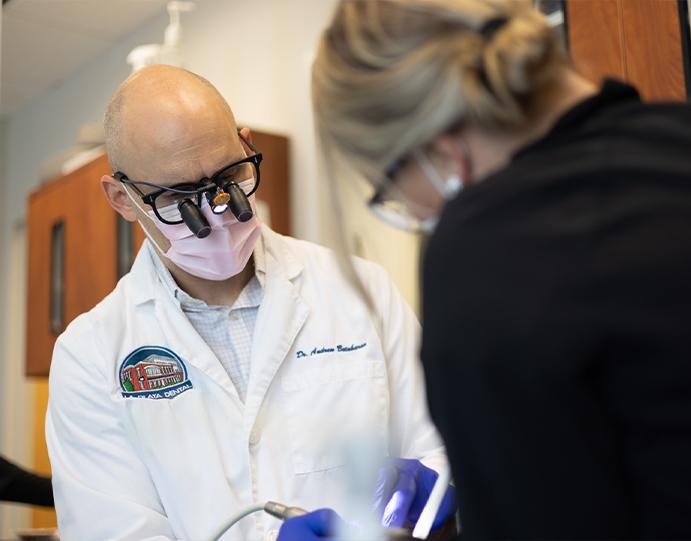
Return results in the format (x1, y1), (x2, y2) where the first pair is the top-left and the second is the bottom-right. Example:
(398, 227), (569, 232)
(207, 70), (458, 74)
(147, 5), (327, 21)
(26, 132), (290, 376)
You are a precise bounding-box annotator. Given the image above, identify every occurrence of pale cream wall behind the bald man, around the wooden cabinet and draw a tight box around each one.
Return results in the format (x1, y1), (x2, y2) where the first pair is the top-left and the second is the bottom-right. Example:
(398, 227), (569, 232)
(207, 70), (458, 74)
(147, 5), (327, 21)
(0, 0), (424, 535)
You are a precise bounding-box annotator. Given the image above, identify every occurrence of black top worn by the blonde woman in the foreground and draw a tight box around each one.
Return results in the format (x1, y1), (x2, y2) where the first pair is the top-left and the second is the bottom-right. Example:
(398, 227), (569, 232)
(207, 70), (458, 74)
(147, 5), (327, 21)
(422, 81), (691, 539)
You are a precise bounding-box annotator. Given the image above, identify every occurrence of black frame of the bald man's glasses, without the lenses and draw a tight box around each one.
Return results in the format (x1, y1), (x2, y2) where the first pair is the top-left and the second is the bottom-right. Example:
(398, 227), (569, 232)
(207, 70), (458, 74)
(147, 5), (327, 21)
(113, 130), (263, 225)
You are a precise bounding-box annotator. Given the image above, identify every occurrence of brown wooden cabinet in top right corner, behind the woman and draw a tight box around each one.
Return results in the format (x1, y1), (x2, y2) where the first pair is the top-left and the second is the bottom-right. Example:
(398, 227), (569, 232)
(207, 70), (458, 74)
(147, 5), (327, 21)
(566, 0), (688, 100)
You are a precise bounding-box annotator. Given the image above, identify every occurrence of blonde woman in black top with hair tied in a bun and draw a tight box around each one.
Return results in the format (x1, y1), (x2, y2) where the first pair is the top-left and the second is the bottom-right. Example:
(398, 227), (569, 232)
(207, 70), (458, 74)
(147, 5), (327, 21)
(280, 0), (691, 539)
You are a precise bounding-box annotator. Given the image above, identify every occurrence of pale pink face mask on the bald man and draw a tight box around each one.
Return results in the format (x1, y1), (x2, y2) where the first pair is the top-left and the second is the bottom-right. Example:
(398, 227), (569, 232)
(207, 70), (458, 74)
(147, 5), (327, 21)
(125, 190), (261, 280)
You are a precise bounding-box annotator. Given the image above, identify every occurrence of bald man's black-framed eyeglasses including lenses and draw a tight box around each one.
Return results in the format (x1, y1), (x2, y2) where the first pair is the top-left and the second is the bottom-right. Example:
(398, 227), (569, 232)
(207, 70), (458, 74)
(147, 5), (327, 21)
(113, 135), (262, 225)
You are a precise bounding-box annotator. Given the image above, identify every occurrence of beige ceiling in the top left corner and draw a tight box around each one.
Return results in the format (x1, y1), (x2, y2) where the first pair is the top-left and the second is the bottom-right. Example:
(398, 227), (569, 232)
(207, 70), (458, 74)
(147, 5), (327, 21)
(0, 0), (167, 115)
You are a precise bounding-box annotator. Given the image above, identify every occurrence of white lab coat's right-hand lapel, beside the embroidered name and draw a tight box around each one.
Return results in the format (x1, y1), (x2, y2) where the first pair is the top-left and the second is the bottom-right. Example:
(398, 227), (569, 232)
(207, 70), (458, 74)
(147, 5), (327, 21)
(245, 229), (310, 423)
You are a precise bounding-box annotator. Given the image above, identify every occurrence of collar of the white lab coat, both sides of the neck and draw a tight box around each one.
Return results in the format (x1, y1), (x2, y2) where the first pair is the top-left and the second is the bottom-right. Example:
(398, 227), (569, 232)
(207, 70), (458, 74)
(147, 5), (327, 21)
(129, 225), (303, 305)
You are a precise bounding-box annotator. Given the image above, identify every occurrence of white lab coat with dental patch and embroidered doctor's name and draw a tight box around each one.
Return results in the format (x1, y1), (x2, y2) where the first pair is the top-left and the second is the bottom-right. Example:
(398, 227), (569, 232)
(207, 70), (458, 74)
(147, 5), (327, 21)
(46, 228), (445, 541)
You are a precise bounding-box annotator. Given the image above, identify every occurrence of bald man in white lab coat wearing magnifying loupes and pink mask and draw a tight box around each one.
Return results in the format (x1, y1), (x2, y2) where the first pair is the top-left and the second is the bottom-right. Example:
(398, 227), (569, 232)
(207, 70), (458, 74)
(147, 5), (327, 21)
(46, 66), (445, 541)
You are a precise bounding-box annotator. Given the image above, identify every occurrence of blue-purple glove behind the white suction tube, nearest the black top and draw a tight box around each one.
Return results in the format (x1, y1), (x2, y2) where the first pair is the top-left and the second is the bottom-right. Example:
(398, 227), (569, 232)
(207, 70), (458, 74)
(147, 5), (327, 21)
(374, 458), (456, 530)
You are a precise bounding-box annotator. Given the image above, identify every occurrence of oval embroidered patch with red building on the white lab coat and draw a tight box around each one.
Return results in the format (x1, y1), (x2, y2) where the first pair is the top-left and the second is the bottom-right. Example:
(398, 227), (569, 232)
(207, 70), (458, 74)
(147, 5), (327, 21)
(120, 346), (192, 399)
